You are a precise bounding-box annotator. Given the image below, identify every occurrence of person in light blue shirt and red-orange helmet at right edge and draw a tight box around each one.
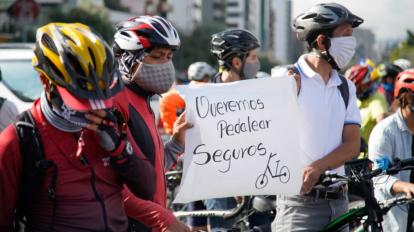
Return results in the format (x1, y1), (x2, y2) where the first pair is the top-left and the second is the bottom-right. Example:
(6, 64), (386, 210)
(368, 71), (414, 232)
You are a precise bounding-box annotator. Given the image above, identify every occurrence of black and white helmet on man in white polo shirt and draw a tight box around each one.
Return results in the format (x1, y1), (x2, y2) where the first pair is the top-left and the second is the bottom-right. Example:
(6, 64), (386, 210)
(293, 3), (364, 44)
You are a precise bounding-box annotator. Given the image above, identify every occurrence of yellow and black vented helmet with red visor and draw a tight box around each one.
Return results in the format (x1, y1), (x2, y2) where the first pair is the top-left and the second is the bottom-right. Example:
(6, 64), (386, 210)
(32, 23), (123, 104)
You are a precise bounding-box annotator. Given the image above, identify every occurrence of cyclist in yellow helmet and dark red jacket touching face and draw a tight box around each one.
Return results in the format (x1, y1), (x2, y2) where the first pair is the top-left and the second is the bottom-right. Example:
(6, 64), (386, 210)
(0, 23), (155, 232)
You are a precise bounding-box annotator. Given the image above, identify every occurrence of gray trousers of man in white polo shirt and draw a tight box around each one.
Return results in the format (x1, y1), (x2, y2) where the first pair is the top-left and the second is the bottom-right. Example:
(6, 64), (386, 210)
(272, 194), (348, 232)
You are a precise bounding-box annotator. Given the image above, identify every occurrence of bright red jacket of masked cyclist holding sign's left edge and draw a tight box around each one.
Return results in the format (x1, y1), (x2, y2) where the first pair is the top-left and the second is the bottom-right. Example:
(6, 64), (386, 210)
(114, 85), (175, 231)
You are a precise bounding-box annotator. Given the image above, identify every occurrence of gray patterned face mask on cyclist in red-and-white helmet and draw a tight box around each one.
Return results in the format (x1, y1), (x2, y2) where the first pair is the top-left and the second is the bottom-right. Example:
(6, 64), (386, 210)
(131, 60), (175, 94)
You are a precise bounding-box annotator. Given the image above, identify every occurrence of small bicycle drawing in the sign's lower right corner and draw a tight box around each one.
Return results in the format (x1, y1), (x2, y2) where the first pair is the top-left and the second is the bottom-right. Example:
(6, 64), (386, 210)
(255, 153), (290, 189)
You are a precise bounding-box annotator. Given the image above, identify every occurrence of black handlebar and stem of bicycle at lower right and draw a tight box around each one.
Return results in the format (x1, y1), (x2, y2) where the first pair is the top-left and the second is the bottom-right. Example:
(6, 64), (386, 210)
(320, 158), (414, 232)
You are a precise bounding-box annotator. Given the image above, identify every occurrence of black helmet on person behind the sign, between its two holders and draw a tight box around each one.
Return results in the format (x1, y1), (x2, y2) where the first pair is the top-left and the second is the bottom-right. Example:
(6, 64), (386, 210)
(210, 29), (260, 68)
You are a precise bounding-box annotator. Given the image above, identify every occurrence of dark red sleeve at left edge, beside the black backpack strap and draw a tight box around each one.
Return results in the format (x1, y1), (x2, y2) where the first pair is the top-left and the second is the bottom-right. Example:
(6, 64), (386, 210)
(0, 125), (21, 231)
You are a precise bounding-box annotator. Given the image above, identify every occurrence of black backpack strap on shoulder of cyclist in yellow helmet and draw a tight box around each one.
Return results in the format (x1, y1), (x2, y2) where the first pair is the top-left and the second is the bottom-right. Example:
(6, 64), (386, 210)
(13, 110), (57, 231)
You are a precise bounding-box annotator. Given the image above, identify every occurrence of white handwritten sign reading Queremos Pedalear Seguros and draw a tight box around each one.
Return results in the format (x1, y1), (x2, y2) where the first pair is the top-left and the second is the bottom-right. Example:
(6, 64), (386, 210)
(175, 77), (301, 203)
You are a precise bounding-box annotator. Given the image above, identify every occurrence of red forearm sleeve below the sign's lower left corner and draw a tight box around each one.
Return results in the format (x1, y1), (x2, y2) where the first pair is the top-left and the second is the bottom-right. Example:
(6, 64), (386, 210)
(122, 187), (175, 232)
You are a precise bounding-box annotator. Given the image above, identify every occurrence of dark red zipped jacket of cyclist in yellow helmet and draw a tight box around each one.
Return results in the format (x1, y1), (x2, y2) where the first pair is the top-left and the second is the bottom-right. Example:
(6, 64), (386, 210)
(0, 100), (151, 231)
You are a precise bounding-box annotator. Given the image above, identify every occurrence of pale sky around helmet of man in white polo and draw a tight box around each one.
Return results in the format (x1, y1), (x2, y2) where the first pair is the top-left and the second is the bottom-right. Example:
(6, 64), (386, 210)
(292, 0), (414, 41)
